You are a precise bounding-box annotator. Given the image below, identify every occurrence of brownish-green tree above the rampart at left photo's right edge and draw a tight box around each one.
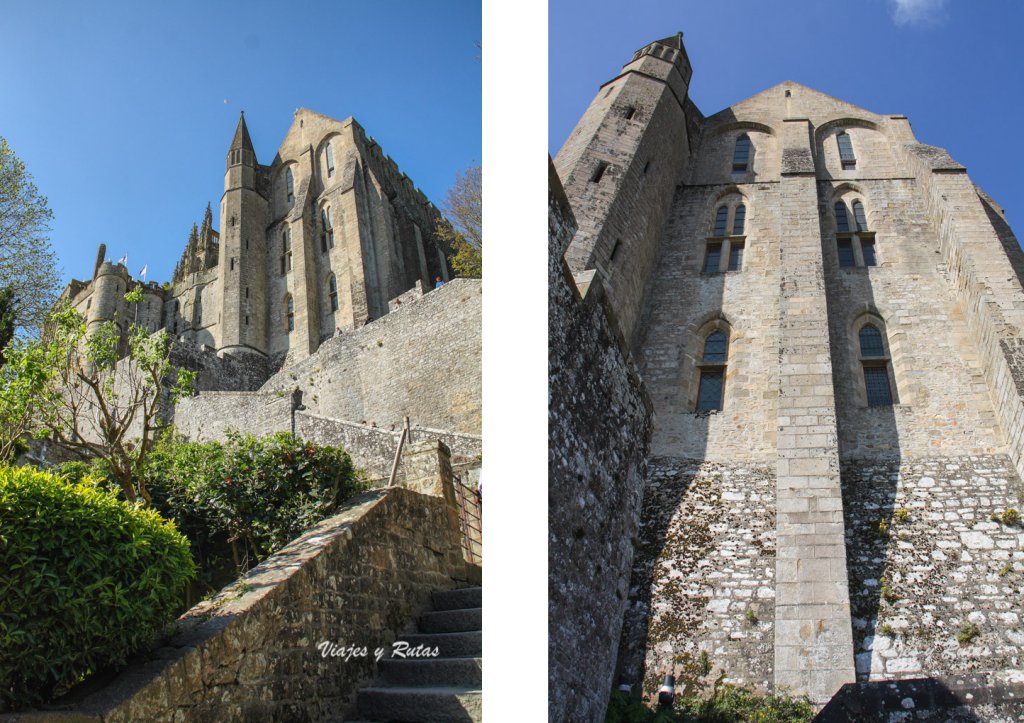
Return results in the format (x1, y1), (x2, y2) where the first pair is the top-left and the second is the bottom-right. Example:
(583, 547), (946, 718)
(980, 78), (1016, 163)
(435, 166), (483, 279)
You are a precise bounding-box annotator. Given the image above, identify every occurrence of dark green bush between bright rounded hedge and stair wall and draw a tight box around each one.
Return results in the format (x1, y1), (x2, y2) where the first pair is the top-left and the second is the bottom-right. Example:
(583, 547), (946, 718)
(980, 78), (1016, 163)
(145, 433), (367, 587)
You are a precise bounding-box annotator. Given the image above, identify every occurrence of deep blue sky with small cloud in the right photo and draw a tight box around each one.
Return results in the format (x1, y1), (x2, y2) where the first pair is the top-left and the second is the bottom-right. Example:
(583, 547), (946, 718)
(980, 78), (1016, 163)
(549, 0), (1024, 228)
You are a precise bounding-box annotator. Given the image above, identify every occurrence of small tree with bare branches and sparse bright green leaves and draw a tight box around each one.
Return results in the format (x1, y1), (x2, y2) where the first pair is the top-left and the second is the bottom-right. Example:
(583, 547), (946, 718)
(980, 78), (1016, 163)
(19, 286), (196, 497)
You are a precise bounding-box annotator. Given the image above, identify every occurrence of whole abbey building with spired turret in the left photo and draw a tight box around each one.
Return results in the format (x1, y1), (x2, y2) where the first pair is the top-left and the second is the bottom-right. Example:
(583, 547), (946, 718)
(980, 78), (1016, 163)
(61, 109), (451, 370)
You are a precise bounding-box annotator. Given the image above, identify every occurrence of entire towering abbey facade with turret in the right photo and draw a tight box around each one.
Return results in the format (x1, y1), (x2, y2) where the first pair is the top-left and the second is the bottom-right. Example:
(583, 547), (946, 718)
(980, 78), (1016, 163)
(552, 36), (1024, 704)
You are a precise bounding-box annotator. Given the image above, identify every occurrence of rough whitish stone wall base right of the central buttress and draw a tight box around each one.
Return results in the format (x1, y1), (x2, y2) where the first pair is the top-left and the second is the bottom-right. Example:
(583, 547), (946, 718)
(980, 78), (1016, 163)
(843, 455), (1024, 685)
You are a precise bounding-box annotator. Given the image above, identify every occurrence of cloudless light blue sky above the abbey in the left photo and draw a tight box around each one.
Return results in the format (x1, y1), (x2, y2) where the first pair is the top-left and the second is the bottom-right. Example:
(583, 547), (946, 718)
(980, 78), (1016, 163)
(0, 0), (482, 281)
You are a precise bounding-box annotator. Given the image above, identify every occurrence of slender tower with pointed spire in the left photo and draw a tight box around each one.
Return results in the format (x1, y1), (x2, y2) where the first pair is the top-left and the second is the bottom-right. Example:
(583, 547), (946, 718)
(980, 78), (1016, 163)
(217, 112), (267, 356)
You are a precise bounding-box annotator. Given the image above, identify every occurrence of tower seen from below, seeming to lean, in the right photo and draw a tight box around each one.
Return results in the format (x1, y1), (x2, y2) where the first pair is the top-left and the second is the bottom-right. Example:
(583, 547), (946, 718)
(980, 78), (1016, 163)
(555, 33), (699, 346)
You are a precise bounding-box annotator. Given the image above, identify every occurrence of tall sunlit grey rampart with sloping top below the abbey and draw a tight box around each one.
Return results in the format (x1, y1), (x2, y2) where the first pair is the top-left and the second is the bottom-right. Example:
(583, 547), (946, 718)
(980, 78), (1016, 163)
(260, 279), (481, 434)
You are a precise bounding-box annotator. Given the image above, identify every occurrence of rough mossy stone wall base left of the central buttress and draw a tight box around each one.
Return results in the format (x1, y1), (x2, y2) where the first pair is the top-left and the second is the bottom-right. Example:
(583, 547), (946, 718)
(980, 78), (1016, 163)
(618, 458), (775, 703)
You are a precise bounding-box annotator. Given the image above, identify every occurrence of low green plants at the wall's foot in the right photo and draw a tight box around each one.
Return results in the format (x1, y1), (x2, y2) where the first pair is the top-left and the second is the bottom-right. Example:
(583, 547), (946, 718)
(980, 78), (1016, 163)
(604, 685), (814, 723)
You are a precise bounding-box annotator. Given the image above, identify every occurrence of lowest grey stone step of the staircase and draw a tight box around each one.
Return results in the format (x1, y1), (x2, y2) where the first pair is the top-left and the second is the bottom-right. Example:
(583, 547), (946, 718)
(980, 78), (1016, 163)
(356, 687), (483, 723)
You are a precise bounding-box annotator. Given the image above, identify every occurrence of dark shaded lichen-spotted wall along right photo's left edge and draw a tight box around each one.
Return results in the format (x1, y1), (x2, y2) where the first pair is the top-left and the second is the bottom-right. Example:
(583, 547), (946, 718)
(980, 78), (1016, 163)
(548, 163), (650, 721)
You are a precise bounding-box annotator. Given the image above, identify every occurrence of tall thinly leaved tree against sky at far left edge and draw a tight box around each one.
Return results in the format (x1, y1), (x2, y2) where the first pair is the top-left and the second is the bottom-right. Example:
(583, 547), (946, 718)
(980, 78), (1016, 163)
(0, 137), (60, 335)
